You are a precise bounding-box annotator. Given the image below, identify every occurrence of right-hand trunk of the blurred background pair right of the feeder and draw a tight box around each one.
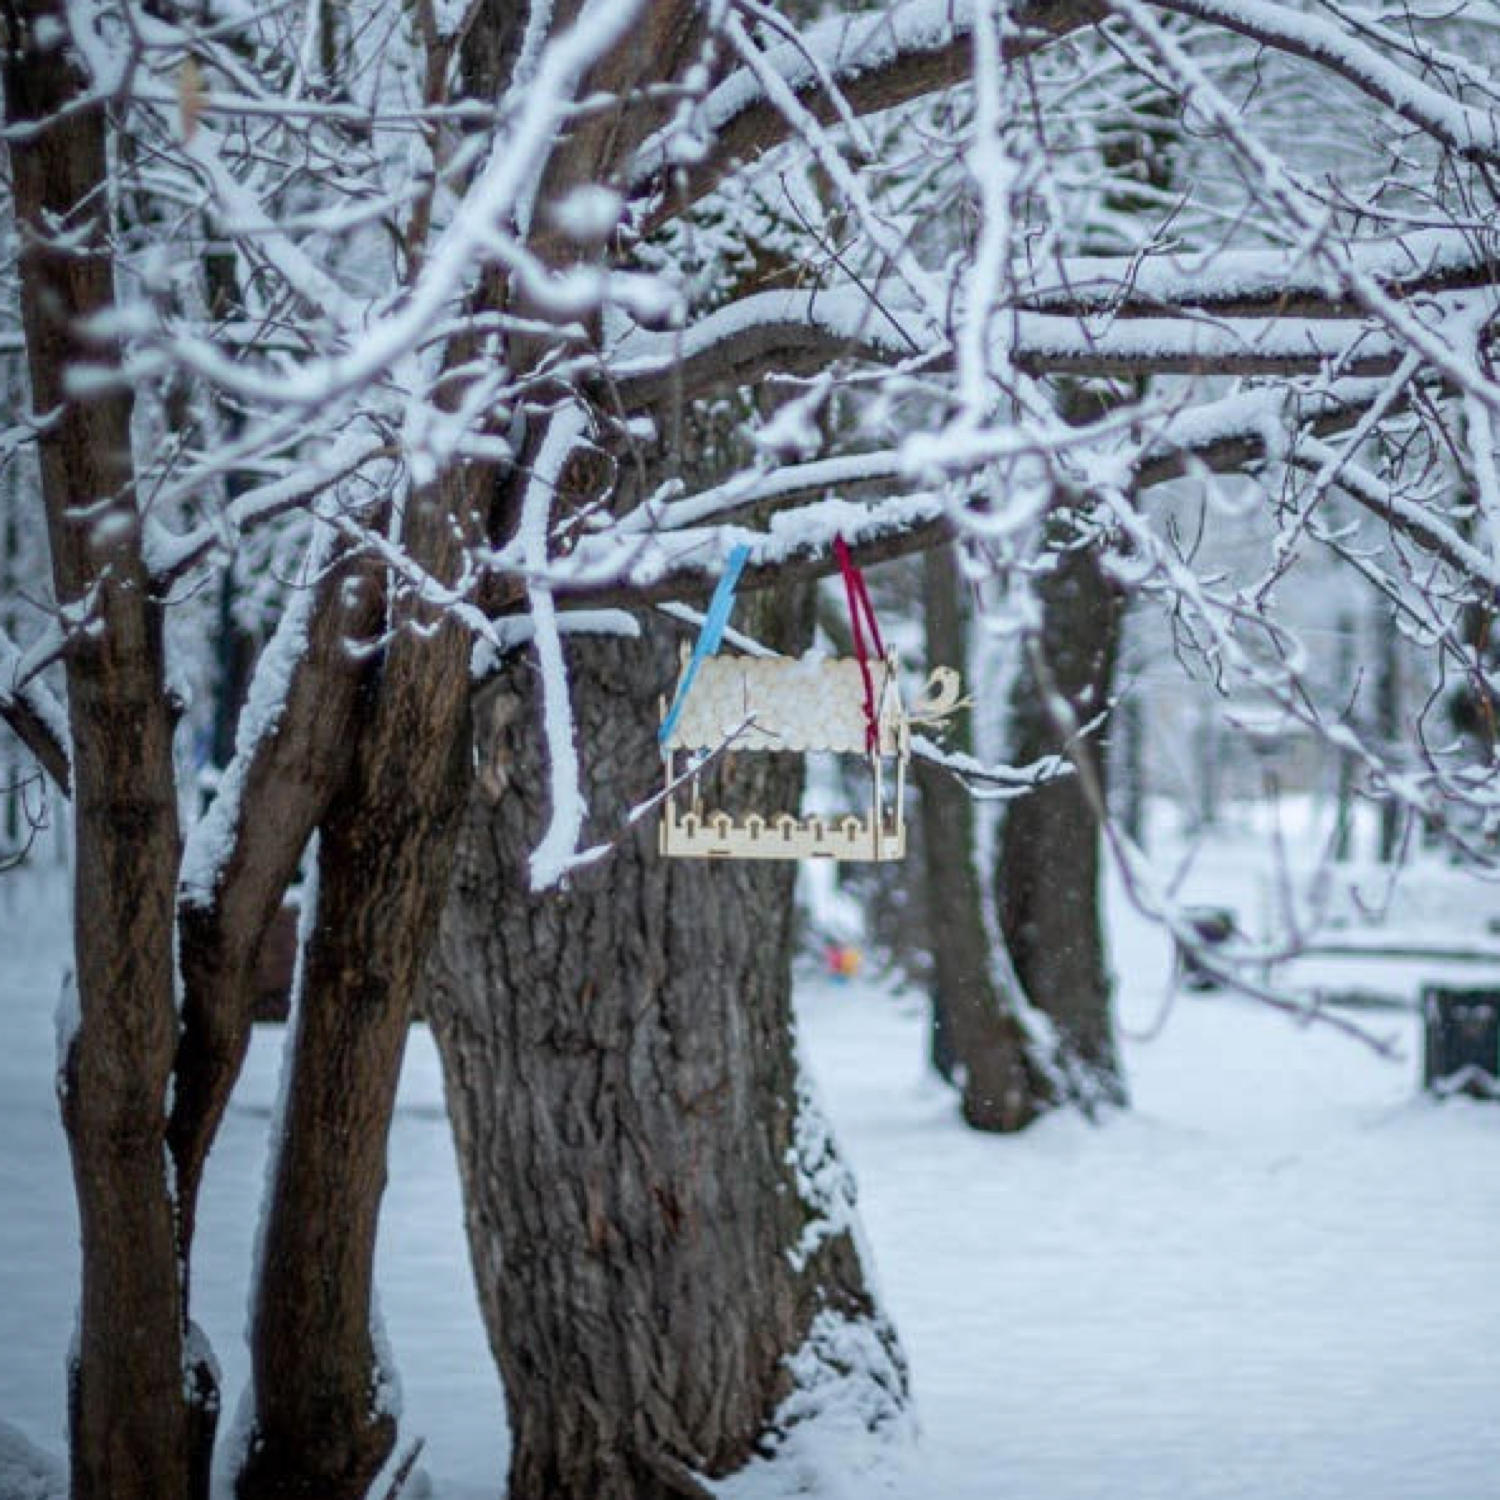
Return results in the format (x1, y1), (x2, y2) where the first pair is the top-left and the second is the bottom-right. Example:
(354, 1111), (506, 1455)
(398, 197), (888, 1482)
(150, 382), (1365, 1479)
(996, 534), (1127, 1109)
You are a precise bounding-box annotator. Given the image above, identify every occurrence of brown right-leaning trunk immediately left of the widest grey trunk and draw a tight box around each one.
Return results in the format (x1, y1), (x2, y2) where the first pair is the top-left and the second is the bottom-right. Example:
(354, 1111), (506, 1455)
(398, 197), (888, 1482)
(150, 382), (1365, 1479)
(239, 474), (474, 1500)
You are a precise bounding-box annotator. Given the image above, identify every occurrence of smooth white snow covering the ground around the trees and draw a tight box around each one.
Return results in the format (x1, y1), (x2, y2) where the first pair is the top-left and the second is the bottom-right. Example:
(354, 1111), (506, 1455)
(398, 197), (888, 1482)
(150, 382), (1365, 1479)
(0, 822), (1500, 1500)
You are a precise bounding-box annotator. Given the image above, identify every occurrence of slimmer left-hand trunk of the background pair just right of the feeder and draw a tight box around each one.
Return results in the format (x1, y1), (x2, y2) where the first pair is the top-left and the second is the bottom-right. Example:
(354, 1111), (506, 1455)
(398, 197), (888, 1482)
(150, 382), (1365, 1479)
(917, 548), (1052, 1131)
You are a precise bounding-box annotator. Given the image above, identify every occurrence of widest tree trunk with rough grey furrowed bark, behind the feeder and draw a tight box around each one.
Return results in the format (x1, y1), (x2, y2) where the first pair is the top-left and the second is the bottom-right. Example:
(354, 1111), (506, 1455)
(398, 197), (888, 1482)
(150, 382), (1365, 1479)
(428, 609), (905, 1500)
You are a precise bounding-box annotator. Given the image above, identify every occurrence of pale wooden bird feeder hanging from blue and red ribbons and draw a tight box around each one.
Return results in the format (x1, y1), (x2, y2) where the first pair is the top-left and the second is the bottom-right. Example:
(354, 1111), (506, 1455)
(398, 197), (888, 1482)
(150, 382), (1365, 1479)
(660, 653), (959, 861)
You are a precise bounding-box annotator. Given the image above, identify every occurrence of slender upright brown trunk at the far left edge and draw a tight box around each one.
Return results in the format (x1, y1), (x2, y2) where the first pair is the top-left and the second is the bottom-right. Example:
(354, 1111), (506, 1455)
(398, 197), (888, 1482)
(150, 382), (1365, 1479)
(0, 0), (191, 1500)
